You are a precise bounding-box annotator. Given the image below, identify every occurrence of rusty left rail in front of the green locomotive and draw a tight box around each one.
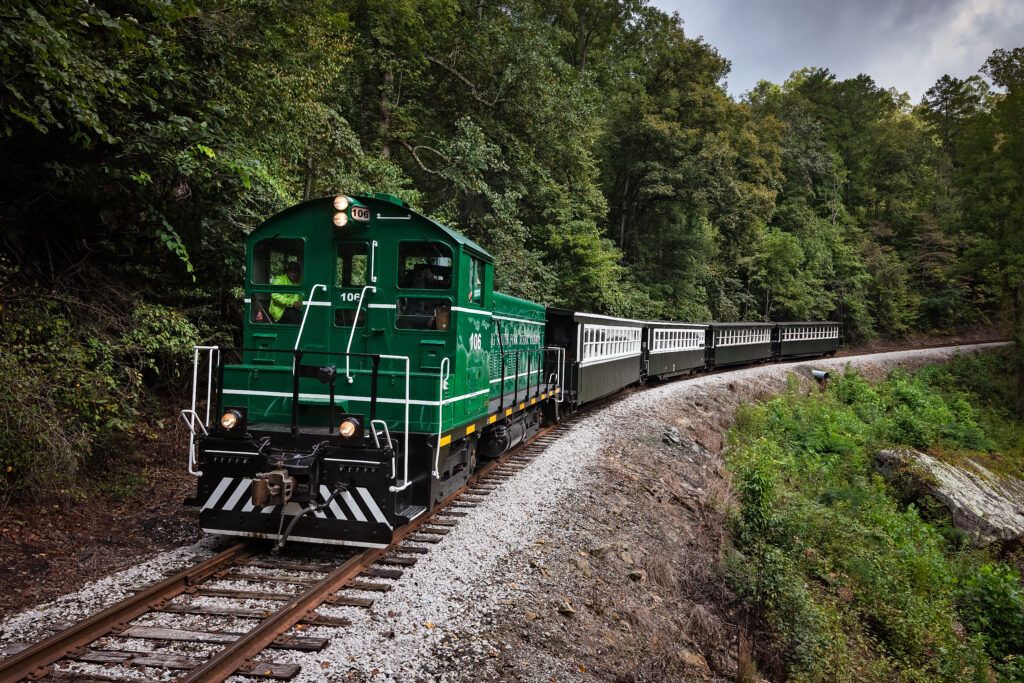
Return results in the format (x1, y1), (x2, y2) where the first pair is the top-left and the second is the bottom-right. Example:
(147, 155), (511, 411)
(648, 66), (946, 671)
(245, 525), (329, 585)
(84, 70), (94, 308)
(0, 543), (248, 683)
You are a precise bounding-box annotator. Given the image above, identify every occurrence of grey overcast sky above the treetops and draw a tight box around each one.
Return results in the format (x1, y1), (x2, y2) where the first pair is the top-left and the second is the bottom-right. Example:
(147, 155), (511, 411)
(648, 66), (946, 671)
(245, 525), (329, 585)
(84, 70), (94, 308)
(651, 0), (1024, 102)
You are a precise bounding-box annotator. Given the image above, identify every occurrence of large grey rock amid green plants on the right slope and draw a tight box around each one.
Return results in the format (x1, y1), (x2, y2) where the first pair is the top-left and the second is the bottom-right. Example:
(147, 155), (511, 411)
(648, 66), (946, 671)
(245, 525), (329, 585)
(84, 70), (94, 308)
(874, 450), (1024, 545)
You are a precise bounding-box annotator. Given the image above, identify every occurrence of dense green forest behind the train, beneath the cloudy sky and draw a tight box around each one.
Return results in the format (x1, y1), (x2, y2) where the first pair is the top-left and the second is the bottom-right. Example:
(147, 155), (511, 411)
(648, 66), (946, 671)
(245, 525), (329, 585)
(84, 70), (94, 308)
(0, 0), (1024, 494)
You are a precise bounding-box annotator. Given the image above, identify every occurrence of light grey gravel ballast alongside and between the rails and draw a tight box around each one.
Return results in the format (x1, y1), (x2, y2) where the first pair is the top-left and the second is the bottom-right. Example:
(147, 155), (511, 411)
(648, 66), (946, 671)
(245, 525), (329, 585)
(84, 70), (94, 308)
(0, 344), (997, 681)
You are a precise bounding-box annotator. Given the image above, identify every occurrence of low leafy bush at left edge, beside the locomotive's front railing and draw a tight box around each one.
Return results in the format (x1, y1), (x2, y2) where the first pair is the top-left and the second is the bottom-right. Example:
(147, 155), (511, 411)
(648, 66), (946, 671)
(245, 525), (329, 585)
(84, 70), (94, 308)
(0, 291), (199, 502)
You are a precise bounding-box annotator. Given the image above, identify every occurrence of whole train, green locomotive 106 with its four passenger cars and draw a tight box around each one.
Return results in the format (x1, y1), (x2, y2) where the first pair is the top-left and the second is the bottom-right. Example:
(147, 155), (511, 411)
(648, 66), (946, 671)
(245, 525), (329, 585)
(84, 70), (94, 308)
(182, 194), (840, 548)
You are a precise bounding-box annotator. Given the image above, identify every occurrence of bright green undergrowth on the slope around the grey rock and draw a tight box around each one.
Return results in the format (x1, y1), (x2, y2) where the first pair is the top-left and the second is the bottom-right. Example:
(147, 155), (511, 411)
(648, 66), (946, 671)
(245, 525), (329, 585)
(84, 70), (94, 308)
(726, 354), (1024, 681)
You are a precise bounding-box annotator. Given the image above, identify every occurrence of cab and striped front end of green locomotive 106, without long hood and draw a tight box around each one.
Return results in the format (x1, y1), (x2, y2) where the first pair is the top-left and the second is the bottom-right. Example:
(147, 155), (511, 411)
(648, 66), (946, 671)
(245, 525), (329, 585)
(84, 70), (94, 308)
(185, 194), (503, 547)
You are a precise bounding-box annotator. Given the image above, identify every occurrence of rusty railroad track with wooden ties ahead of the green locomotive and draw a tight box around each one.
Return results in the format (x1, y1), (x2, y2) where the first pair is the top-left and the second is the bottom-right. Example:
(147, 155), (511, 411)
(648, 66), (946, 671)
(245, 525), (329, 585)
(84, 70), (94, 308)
(0, 423), (569, 683)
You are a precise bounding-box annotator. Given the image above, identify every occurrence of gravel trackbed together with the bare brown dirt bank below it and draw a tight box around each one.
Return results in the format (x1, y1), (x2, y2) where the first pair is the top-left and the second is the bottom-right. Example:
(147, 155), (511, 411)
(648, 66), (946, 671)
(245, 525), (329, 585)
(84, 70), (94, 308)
(2, 349), (1003, 681)
